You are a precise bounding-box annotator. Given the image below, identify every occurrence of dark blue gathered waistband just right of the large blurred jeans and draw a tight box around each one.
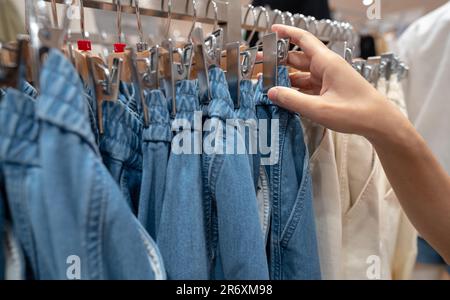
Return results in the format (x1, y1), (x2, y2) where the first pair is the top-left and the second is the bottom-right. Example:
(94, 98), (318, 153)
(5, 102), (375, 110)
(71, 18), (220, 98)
(100, 101), (142, 169)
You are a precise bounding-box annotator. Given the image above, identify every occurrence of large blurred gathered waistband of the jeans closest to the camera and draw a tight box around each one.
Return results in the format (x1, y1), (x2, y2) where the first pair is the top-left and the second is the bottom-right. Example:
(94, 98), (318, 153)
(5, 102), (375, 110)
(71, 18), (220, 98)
(37, 49), (98, 153)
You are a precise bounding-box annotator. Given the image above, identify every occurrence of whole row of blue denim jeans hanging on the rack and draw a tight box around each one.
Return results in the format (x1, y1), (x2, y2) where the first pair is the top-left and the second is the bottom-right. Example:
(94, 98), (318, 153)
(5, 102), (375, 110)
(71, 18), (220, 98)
(0, 50), (320, 280)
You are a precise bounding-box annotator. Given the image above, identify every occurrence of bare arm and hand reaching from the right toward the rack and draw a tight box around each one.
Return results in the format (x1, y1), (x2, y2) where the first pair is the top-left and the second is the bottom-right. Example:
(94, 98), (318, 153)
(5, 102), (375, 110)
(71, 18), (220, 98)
(269, 25), (450, 263)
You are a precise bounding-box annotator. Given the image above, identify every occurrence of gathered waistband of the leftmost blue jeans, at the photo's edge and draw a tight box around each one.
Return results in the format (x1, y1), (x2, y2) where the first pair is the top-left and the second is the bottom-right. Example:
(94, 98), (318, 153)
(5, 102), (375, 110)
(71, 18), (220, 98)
(0, 89), (39, 166)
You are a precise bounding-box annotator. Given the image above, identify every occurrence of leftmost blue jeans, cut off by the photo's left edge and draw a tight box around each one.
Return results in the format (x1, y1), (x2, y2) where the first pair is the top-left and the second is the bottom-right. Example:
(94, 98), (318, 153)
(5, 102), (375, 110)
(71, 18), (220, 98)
(0, 89), (41, 279)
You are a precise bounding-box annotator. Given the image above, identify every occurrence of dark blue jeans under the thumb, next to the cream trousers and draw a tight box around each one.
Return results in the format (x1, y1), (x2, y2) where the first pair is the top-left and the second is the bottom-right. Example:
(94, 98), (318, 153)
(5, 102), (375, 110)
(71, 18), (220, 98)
(255, 66), (321, 280)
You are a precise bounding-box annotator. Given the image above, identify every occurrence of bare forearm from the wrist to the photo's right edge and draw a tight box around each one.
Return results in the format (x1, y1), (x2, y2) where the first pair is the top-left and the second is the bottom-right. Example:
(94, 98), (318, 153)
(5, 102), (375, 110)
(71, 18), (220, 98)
(370, 109), (450, 262)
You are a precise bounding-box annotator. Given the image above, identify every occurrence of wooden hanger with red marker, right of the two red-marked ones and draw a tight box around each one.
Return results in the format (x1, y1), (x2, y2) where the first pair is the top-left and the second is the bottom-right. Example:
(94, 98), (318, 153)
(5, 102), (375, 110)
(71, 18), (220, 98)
(108, 0), (132, 83)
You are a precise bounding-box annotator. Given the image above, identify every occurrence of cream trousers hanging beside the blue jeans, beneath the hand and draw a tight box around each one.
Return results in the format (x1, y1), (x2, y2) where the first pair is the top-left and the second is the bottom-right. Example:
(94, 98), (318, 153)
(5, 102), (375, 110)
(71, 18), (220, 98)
(304, 77), (417, 279)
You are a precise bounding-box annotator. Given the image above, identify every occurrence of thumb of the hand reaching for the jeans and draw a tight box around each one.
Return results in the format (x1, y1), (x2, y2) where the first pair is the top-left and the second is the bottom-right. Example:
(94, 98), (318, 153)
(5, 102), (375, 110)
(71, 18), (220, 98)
(268, 87), (324, 121)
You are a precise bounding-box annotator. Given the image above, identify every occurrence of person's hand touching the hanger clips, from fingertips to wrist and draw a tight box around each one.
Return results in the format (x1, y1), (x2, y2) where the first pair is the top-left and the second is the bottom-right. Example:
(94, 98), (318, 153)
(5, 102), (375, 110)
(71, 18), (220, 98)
(269, 25), (409, 144)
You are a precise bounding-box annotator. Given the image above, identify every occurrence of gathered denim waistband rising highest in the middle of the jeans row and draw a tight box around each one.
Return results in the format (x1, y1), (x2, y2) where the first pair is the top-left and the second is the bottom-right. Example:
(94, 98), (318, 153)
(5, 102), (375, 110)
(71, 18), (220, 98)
(207, 67), (234, 121)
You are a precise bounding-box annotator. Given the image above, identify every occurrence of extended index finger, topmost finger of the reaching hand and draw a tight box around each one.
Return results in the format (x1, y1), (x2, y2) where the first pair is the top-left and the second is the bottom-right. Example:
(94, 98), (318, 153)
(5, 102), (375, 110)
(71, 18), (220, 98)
(272, 24), (328, 57)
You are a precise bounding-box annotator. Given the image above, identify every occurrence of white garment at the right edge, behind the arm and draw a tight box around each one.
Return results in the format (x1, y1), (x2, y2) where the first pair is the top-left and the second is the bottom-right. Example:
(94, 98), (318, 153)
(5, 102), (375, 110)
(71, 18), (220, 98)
(397, 2), (450, 174)
